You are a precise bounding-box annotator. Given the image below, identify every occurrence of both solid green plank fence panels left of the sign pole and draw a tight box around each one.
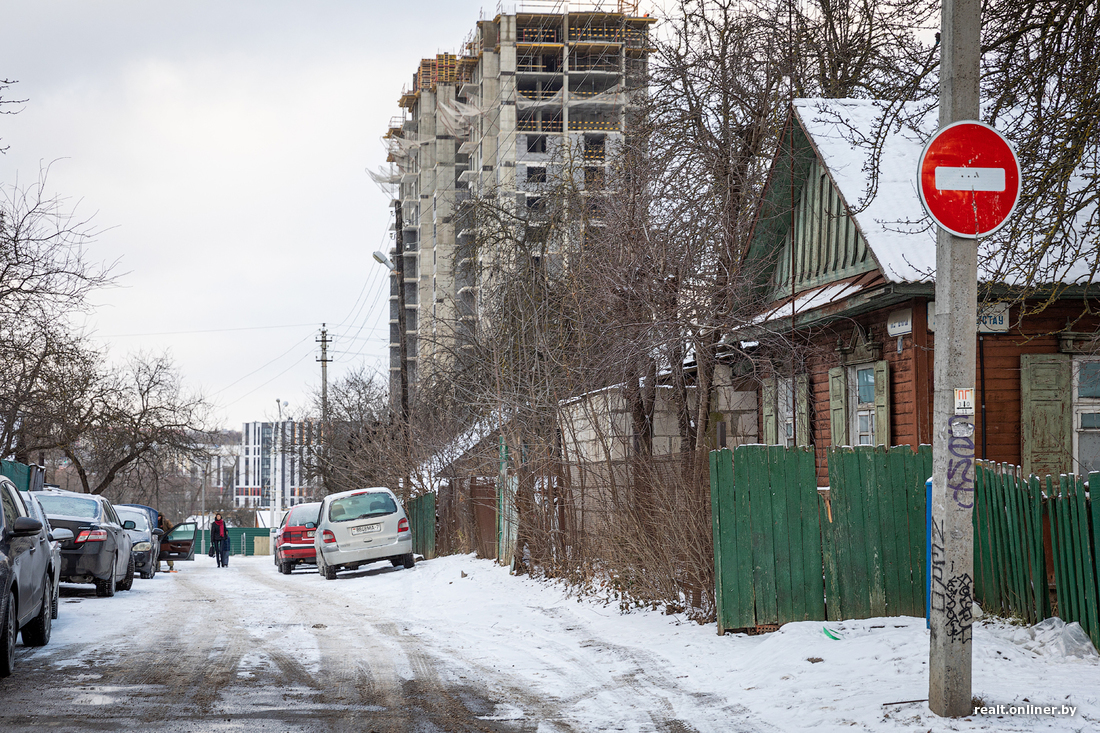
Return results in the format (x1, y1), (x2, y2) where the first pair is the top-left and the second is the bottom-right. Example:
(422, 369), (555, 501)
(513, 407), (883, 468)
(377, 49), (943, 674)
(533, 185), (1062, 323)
(711, 446), (932, 632)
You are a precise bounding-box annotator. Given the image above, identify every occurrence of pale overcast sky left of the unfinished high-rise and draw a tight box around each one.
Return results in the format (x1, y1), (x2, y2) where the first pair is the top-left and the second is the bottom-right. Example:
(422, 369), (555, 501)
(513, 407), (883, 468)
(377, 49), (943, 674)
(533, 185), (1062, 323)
(0, 0), (496, 429)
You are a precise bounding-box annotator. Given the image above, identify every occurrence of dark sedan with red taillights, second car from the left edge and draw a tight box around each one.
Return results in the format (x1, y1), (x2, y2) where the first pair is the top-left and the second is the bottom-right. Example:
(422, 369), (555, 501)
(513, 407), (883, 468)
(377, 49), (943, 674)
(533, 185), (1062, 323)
(36, 489), (135, 598)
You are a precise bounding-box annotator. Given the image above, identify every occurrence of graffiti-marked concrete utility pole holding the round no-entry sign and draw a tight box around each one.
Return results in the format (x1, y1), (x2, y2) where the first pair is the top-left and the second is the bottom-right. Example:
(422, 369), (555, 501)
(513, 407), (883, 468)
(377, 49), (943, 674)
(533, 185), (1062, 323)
(928, 0), (981, 716)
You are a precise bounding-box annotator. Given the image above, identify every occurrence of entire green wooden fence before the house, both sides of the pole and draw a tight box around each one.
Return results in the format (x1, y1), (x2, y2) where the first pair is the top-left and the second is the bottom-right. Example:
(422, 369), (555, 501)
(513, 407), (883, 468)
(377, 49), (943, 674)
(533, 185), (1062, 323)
(711, 446), (1100, 646)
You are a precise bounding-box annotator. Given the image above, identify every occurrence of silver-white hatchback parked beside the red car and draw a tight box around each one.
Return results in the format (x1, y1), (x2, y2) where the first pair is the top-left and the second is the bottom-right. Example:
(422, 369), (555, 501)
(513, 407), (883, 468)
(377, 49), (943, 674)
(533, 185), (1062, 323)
(314, 486), (415, 580)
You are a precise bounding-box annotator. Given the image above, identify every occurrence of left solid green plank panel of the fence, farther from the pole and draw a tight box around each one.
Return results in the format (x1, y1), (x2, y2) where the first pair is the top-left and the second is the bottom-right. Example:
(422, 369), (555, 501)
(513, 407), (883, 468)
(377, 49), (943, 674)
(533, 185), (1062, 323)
(711, 446), (825, 633)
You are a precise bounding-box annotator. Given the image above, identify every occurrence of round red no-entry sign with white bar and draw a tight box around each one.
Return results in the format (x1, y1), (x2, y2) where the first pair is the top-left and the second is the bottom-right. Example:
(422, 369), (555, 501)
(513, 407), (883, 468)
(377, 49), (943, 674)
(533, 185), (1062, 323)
(917, 120), (1020, 239)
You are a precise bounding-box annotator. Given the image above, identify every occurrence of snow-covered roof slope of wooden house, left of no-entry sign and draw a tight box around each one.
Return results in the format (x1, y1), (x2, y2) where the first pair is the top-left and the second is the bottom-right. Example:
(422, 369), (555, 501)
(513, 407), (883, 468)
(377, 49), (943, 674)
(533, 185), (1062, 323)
(794, 99), (936, 283)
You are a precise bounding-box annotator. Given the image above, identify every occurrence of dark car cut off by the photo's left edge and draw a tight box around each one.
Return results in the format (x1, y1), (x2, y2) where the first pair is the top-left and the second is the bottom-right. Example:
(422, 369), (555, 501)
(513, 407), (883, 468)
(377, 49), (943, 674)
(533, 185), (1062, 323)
(0, 477), (53, 677)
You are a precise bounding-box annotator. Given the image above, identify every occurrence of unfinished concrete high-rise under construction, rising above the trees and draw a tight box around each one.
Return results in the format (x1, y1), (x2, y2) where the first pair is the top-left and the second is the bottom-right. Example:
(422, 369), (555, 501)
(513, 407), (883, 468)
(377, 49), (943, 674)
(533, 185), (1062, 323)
(386, 0), (653, 403)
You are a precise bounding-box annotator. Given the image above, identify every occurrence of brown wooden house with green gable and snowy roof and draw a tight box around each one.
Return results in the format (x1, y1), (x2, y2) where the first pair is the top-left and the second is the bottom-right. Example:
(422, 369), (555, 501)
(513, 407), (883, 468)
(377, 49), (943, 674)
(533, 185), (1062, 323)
(739, 100), (1100, 484)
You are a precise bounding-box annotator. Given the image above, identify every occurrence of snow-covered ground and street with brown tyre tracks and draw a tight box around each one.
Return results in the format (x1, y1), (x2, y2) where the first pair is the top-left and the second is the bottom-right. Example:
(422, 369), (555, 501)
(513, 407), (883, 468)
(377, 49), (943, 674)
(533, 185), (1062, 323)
(0, 556), (1100, 733)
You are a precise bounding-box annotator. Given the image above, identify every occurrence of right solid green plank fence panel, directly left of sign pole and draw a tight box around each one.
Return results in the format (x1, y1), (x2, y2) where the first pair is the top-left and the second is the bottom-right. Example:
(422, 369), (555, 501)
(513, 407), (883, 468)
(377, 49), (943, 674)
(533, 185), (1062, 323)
(822, 446), (932, 621)
